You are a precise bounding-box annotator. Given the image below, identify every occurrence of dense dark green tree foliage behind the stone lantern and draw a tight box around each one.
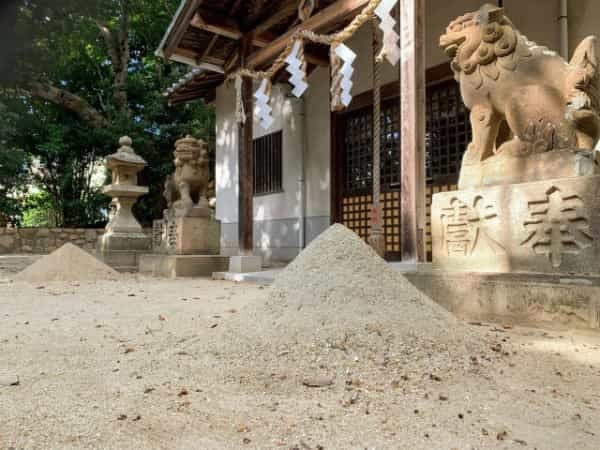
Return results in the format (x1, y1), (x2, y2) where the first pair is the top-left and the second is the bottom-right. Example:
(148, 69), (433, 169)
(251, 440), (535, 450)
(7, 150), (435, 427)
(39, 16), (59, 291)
(0, 0), (214, 226)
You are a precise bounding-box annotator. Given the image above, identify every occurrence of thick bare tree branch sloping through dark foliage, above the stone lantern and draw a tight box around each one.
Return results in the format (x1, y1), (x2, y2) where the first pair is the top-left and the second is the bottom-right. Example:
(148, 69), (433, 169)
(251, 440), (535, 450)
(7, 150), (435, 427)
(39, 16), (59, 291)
(26, 81), (108, 128)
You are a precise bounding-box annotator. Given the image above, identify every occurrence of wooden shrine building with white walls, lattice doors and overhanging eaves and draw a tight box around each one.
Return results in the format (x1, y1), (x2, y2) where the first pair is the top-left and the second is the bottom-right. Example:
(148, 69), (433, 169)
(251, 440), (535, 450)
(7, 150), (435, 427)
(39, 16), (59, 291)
(157, 0), (600, 263)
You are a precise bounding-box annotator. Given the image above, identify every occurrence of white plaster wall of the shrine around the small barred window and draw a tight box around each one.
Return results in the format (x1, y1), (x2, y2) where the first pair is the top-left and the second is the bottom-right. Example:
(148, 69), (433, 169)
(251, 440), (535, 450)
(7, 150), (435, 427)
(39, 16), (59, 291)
(215, 68), (330, 229)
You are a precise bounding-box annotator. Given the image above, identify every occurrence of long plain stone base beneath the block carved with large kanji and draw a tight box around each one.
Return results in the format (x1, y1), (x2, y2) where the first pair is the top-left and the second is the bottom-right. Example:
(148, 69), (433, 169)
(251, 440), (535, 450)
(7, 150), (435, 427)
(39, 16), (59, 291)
(404, 271), (600, 329)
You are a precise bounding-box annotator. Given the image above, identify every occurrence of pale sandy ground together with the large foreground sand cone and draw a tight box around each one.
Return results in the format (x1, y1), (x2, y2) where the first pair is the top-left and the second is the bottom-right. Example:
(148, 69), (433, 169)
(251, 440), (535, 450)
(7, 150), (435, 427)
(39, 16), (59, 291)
(0, 239), (600, 450)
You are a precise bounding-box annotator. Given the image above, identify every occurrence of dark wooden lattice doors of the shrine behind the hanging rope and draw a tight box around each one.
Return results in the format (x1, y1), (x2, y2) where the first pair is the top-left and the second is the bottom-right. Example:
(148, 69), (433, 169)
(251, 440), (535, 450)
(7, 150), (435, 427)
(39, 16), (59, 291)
(334, 80), (471, 261)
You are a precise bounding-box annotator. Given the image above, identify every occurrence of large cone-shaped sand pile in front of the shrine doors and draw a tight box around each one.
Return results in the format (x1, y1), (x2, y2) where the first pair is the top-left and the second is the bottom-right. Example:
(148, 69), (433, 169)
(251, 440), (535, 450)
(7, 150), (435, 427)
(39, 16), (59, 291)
(209, 225), (486, 386)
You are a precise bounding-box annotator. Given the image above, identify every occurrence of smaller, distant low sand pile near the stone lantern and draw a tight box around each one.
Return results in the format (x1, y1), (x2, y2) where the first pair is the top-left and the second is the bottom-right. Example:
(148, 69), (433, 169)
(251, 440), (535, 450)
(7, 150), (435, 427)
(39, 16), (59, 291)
(14, 244), (118, 283)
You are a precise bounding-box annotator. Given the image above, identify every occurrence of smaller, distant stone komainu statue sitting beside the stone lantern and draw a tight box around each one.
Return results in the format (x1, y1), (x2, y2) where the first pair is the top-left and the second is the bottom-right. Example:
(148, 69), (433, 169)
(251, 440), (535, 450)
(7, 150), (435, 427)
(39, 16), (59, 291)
(164, 136), (210, 219)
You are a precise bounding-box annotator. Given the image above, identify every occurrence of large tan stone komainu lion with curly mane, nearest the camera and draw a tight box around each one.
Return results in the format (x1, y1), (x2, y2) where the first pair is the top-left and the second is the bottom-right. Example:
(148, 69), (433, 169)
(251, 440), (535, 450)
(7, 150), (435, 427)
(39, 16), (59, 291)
(440, 5), (600, 164)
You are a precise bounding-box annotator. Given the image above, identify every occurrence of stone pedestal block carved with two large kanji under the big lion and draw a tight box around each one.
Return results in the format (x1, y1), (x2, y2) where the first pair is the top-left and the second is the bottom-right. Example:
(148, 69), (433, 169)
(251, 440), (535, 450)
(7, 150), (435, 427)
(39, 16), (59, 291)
(431, 175), (600, 274)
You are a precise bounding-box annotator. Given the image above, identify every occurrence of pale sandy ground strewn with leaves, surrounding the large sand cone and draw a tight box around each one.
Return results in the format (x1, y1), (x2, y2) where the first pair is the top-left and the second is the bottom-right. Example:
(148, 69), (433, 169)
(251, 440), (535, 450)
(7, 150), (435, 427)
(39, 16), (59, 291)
(0, 259), (600, 450)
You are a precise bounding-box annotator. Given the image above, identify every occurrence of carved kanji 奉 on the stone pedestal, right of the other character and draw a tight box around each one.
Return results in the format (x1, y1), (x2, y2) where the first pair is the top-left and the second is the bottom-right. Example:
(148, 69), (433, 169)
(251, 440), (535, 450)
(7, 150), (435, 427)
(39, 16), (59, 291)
(521, 187), (594, 268)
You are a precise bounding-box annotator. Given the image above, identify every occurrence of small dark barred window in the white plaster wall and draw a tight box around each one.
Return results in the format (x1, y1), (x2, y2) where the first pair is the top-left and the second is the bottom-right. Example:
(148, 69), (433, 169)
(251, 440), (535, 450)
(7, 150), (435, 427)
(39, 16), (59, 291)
(253, 131), (283, 195)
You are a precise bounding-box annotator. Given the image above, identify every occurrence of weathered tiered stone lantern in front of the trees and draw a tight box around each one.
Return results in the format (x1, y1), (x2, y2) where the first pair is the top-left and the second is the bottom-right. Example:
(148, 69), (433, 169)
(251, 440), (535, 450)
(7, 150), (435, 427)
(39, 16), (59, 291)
(98, 136), (152, 271)
